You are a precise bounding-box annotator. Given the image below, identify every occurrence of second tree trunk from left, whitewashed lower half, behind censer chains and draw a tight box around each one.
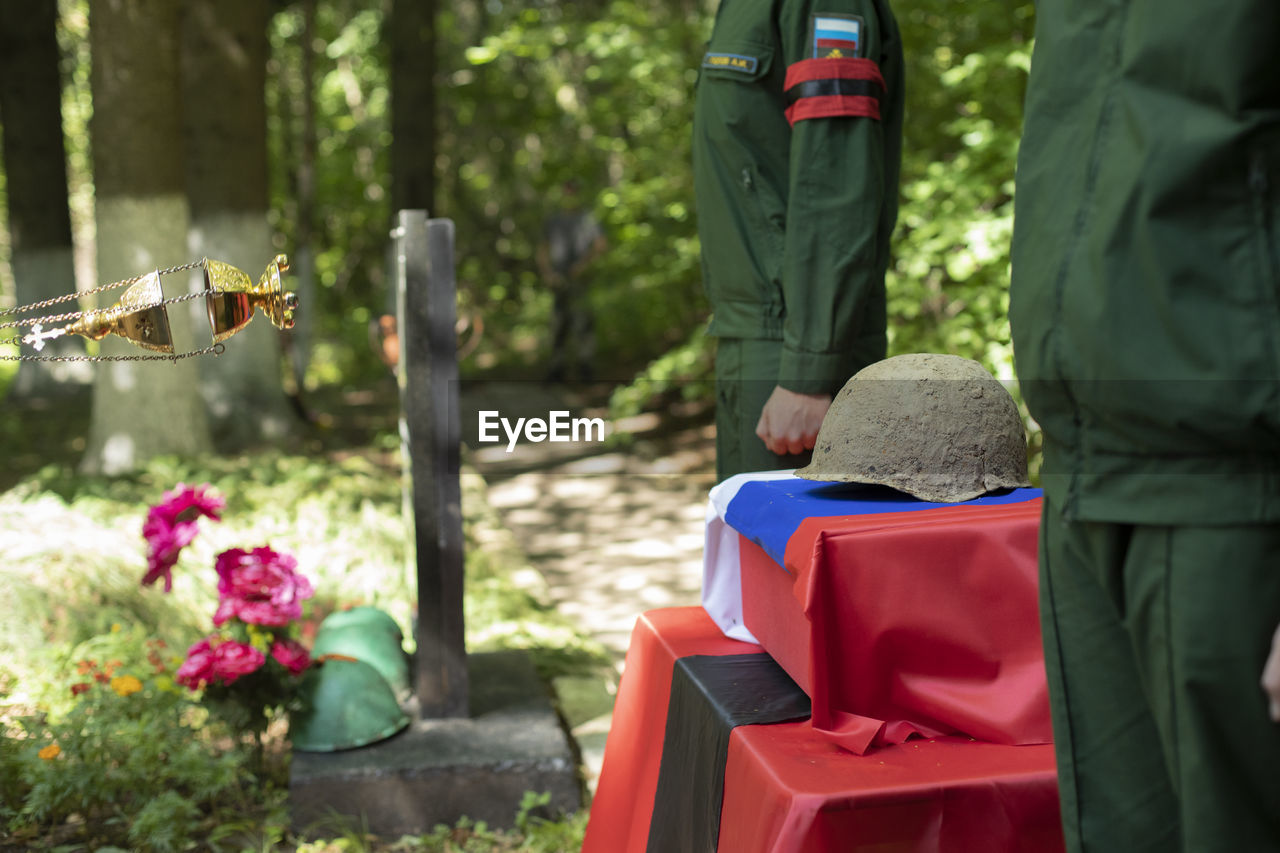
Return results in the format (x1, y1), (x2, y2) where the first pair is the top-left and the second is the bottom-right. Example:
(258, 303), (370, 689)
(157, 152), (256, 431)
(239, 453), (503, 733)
(81, 0), (212, 474)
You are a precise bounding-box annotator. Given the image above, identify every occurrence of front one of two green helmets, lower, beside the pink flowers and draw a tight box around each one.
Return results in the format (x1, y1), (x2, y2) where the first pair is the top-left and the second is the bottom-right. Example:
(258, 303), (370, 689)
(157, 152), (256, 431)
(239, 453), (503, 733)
(289, 657), (408, 752)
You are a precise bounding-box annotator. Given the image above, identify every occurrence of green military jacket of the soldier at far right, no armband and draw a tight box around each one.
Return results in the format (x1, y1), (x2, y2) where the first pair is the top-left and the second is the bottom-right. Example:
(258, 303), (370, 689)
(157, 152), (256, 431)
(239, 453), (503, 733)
(1010, 0), (1280, 524)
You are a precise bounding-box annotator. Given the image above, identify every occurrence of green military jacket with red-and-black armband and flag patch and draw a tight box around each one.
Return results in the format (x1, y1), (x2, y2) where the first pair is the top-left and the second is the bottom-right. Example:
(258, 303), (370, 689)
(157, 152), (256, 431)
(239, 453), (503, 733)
(694, 0), (902, 393)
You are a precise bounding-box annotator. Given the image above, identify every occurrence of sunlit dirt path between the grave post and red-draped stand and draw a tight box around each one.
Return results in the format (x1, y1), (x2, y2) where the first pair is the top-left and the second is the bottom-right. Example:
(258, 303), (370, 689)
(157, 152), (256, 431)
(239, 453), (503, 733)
(462, 383), (716, 790)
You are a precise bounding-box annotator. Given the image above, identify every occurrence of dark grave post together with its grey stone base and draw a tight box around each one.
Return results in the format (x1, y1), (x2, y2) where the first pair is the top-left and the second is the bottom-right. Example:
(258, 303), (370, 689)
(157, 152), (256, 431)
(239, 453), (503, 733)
(289, 210), (582, 836)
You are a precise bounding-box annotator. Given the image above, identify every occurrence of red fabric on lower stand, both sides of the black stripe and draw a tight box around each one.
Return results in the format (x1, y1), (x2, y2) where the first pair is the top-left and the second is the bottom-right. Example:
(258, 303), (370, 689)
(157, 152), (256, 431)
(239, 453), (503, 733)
(582, 604), (1062, 853)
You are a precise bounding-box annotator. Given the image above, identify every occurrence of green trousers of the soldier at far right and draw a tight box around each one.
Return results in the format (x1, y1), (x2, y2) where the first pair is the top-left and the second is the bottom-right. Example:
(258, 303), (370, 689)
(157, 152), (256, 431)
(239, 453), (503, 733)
(1041, 501), (1280, 853)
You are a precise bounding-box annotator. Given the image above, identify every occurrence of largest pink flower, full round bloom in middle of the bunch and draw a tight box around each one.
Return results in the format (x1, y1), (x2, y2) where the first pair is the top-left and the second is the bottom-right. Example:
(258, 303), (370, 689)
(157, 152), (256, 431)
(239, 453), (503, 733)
(214, 547), (315, 626)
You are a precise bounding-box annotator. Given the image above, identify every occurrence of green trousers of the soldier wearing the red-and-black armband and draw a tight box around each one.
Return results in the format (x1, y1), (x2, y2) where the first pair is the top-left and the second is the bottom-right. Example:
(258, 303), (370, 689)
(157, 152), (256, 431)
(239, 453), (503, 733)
(716, 338), (812, 480)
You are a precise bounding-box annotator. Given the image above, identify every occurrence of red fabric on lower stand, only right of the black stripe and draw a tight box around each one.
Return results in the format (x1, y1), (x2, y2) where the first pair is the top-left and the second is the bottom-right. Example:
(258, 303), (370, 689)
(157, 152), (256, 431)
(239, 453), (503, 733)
(717, 722), (1062, 853)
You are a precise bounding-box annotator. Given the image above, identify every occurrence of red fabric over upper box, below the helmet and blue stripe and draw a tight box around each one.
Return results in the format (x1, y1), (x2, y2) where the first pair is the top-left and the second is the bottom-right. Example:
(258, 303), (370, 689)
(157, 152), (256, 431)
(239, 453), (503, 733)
(740, 500), (1052, 754)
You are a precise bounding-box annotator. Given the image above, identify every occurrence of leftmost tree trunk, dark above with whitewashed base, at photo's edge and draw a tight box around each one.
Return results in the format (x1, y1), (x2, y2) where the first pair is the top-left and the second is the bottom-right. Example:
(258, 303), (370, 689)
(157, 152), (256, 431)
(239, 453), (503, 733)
(0, 0), (91, 401)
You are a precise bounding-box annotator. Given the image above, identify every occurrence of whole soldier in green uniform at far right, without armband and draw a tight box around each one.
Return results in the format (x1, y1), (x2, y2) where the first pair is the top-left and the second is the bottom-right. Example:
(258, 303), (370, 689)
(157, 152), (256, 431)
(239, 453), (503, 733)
(1010, 0), (1280, 853)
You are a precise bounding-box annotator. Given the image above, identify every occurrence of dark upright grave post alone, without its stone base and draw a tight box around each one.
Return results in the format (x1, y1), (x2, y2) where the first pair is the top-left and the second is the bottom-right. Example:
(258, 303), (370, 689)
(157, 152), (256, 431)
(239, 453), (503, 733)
(392, 210), (468, 719)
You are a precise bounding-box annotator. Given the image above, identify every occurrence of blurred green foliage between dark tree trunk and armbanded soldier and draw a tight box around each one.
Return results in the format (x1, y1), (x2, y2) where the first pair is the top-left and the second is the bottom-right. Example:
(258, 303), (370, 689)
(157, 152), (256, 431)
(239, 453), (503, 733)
(427, 0), (707, 375)
